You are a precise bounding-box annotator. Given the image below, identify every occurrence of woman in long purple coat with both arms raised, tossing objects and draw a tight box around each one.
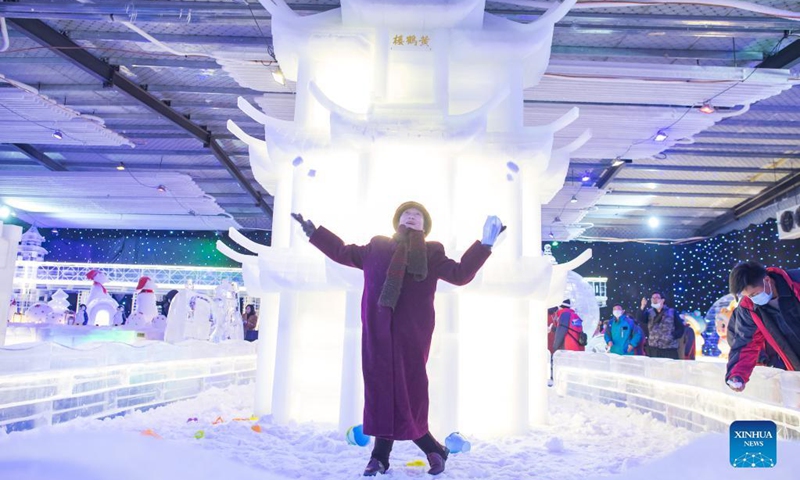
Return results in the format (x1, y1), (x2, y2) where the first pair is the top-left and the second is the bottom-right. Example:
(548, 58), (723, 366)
(292, 202), (505, 476)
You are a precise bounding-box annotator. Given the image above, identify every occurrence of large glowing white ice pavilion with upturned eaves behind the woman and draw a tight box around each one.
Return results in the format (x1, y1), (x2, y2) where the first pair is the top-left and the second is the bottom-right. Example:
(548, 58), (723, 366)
(219, 0), (591, 435)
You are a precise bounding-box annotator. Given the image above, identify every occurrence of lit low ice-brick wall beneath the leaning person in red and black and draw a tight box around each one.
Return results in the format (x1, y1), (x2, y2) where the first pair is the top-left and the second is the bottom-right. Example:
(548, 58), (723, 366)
(553, 351), (800, 439)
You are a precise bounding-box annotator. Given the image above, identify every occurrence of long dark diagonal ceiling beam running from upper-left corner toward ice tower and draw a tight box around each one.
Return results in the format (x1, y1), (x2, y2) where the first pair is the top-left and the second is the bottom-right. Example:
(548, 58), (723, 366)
(9, 19), (272, 217)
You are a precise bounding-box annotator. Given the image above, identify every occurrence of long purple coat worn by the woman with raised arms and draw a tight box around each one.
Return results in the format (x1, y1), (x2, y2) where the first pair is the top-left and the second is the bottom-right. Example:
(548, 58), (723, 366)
(310, 227), (491, 440)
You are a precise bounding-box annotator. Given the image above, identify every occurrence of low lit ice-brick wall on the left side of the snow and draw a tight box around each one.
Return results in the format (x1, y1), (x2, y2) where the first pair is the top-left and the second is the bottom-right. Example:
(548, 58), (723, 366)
(0, 341), (256, 432)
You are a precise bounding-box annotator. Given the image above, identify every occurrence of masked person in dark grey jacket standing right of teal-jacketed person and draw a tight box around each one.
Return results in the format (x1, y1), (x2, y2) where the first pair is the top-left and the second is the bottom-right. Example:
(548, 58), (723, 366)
(639, 292), (684, 360)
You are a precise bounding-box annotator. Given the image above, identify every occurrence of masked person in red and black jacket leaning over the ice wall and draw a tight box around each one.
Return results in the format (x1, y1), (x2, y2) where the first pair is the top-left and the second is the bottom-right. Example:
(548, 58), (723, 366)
(725, 261), (800, 392)
